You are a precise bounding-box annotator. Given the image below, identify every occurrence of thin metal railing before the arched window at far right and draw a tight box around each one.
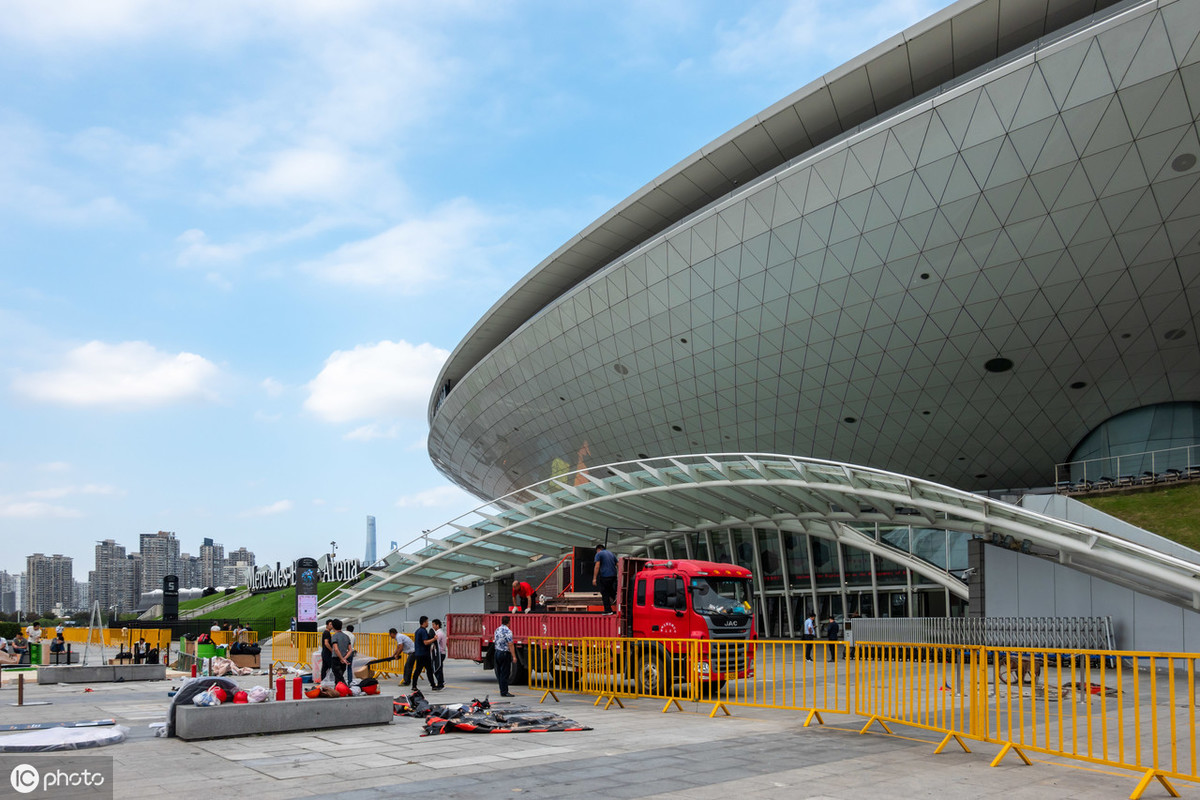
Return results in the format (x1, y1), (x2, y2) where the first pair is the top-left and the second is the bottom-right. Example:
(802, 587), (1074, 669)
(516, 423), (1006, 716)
(1054, 445), (1200, 494)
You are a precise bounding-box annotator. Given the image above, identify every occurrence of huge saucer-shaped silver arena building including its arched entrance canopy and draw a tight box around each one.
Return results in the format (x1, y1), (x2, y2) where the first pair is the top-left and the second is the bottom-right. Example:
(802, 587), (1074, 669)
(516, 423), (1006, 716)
(326, 0), (1200, 646)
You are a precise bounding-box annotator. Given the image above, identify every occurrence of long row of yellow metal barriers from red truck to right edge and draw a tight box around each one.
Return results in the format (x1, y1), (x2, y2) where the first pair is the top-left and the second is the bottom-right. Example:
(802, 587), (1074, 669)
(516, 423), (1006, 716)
(527, 637), (1200, 800)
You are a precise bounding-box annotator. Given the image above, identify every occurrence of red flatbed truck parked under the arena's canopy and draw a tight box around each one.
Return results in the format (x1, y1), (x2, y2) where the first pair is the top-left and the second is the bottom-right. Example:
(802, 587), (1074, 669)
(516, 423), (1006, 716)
(446, 557), (755, 694)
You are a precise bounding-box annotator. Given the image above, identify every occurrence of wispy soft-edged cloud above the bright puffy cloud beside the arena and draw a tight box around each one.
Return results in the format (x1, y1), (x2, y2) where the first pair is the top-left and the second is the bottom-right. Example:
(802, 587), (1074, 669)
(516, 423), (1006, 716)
(302, 198), (502, 294)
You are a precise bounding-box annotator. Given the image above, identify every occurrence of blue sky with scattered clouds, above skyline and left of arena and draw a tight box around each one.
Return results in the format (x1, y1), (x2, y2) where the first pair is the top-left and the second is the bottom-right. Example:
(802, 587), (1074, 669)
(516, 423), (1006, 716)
(0, 0), (940, 579)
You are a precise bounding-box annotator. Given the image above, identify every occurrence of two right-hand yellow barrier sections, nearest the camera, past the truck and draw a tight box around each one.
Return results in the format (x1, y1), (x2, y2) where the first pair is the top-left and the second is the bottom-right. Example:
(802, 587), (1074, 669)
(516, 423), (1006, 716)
(856, 643), (1200, 800)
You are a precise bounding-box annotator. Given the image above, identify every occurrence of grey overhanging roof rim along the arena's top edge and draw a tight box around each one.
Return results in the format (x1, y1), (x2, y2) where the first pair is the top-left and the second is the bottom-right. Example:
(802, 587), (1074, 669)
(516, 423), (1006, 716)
(430, 0), (1116, 421)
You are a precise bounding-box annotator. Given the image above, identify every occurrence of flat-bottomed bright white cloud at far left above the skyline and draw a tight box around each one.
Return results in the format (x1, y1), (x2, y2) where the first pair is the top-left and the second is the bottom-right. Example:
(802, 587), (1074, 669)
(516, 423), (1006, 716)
(13, 342), (220, 409)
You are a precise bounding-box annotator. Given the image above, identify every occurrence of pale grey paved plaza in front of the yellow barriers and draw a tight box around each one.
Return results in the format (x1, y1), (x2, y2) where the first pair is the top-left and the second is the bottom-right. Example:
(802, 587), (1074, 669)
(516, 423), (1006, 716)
(0, 662), (1166, 800)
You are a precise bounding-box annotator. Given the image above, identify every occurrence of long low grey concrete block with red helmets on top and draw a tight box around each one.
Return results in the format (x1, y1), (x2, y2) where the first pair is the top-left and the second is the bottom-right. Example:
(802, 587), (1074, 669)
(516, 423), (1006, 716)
(175, 694), (392, 740)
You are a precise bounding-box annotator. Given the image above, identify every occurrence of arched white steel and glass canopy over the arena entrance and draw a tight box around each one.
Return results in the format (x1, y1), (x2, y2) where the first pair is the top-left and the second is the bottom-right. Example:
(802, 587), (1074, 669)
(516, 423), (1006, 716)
(323, 453), (1200, 616)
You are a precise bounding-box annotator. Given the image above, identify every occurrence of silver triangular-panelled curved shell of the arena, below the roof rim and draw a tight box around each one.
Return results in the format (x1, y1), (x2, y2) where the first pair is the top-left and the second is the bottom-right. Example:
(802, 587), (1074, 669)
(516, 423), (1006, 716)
(428, 0), (1200, 497)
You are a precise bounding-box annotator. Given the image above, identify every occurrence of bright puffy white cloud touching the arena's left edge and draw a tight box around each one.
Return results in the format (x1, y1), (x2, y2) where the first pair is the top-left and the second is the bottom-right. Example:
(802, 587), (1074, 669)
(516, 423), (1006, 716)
(304, 341), (450, 422)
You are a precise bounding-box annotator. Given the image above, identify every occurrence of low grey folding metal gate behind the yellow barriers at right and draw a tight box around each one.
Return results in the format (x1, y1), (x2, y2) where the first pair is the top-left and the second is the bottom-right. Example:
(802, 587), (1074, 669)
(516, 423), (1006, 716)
(852, 616), (1116, 650)
